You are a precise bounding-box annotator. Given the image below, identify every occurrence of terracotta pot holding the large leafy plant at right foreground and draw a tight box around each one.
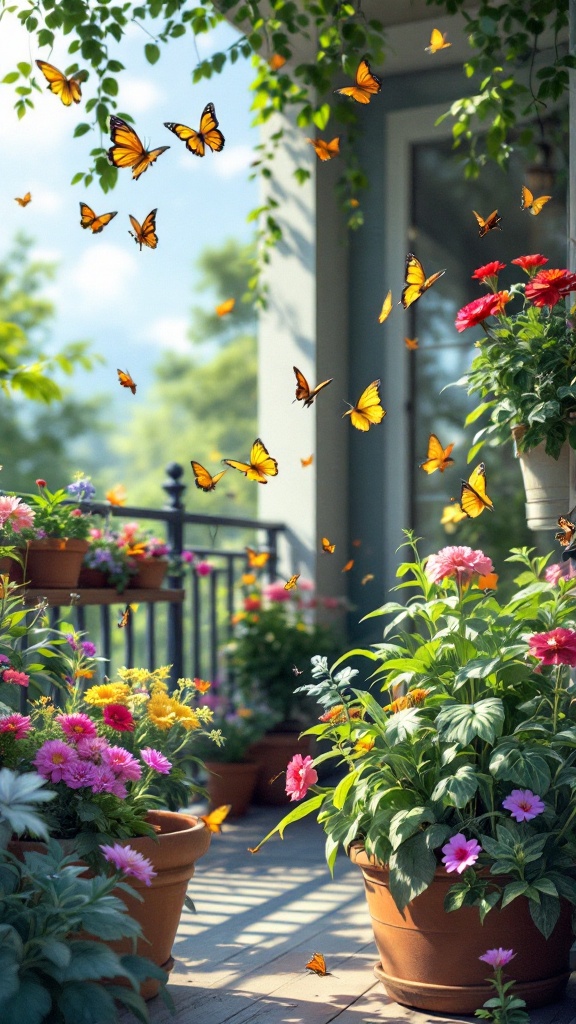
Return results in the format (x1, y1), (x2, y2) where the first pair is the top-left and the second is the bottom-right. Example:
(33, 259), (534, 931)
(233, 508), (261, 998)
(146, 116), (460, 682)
(349, 843), (573, 1014)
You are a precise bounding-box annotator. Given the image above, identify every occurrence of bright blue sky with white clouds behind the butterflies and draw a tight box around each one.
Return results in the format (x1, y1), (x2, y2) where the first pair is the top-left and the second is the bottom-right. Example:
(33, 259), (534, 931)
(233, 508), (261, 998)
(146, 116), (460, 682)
(0, 15), (257, 394)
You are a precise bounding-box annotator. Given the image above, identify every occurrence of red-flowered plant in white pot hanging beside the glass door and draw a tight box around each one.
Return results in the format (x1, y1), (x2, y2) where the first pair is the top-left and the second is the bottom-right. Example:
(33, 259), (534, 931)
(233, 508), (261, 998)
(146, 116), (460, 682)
(456, 254), (576, 529)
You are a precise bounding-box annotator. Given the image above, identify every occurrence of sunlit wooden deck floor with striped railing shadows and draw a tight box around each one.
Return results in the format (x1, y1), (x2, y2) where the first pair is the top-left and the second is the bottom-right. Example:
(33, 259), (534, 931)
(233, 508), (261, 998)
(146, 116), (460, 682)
(140, 808), (576, 1024)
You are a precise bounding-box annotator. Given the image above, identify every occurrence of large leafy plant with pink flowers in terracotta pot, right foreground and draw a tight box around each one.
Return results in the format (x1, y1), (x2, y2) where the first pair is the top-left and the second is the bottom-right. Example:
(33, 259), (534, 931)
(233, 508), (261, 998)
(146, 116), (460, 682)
(255, 538), (576, 1014)
